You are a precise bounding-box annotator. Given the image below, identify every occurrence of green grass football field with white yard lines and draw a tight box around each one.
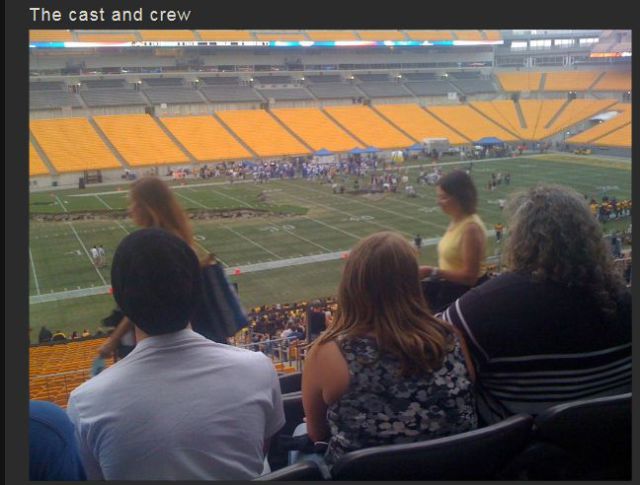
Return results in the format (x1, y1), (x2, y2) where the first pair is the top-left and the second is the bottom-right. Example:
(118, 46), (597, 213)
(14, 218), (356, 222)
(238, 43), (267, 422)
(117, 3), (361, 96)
(29, 154), (631, 341)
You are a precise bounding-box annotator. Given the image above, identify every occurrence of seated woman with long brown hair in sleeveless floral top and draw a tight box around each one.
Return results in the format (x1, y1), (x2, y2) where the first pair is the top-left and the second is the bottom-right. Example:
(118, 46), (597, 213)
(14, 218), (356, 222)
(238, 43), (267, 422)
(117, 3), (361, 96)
(298, 232), (477, 466)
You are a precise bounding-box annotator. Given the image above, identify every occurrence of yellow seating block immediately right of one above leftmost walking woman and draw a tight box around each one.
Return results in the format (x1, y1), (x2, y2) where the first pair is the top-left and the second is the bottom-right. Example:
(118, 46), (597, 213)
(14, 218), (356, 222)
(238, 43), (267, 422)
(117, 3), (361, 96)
(160, 116), (253, 162)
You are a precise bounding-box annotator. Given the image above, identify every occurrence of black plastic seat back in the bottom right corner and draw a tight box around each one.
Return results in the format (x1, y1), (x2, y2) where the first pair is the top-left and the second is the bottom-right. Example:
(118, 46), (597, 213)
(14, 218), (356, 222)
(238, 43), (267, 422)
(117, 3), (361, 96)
(508, 393), (631, 480)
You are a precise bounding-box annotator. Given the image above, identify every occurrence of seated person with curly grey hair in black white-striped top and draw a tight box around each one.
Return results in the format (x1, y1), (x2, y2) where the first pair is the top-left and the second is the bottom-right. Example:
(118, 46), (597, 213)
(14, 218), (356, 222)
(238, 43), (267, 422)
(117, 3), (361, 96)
(441, 185), (631, 423)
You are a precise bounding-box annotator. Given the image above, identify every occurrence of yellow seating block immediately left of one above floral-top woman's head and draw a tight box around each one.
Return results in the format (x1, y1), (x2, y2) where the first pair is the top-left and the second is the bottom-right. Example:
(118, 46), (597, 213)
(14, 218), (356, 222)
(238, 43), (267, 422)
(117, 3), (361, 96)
(271, 108), (364, 152)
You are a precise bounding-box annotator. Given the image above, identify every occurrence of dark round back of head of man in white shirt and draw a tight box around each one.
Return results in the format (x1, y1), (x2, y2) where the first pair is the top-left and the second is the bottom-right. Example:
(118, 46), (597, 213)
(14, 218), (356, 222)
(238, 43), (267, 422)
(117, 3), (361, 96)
(111, 228), (202, 335)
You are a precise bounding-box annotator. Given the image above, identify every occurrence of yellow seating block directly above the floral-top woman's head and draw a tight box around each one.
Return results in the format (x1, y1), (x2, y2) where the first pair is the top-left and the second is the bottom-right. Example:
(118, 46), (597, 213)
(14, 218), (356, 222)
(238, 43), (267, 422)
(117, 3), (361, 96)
(324, 106), (415, 149)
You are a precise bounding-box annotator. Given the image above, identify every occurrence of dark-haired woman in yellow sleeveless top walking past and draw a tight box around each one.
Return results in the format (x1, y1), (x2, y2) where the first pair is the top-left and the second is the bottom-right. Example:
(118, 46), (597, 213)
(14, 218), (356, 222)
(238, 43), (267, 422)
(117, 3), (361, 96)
(420, 170), (487, 312)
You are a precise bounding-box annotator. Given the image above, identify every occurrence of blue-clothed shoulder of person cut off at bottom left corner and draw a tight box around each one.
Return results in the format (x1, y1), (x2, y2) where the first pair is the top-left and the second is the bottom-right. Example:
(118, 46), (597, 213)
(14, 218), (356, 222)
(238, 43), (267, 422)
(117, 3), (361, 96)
(29, 401), (86, 482)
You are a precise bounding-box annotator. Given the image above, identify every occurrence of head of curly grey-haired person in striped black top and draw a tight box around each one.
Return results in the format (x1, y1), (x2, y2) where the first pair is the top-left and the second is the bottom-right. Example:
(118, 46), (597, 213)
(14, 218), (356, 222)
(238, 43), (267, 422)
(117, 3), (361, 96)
(504, 185), (624, 317)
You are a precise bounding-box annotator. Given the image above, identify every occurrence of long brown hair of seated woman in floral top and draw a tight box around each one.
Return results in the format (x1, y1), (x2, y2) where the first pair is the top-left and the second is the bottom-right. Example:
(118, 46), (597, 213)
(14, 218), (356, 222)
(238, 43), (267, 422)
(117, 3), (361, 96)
(314, 232), (453, 376)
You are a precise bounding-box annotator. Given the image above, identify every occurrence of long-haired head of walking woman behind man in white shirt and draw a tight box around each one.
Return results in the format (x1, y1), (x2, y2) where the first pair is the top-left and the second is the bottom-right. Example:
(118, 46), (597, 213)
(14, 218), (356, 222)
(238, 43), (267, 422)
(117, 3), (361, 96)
(129, 176), (193, 243)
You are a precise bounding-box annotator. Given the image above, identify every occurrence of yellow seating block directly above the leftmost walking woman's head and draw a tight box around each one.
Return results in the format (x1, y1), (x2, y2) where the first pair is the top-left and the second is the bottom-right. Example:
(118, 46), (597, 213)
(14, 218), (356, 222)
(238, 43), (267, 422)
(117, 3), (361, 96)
(94, 114), (189, 167)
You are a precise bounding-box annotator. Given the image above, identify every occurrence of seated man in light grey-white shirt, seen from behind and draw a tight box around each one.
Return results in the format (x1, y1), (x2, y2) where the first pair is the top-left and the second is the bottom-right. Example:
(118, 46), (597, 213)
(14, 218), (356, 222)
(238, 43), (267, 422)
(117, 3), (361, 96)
(67, 229), (284, 480)
